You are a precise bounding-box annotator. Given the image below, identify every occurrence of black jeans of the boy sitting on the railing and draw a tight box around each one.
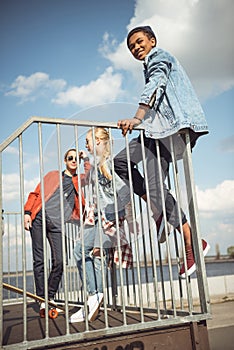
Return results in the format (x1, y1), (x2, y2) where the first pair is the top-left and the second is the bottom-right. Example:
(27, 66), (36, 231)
(114, 136), (187, 228)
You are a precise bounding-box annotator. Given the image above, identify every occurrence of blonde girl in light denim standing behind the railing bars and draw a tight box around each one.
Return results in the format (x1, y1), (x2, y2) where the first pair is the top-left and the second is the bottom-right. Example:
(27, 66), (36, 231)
(70, 127), (132, 323)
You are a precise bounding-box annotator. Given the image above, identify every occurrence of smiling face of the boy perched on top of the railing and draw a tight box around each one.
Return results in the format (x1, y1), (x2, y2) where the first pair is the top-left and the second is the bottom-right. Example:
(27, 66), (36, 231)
(129, 31), (156, 61)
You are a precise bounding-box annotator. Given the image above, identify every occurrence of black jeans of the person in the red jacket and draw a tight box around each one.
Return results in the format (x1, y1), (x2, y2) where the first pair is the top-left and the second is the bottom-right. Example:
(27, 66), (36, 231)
(31, 211), (63, 299)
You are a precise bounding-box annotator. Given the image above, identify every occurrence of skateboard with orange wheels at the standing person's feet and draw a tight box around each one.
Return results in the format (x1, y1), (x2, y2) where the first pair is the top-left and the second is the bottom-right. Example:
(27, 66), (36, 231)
(2, 283), (65, 319)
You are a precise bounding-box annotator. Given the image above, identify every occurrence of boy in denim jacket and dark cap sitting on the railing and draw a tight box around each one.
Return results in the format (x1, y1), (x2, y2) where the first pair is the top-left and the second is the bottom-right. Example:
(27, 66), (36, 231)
(115, 26), (209, 278)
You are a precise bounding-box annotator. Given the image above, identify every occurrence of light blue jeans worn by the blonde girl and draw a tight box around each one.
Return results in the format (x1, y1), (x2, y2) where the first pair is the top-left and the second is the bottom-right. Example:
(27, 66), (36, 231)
(74, 225), (112, 295)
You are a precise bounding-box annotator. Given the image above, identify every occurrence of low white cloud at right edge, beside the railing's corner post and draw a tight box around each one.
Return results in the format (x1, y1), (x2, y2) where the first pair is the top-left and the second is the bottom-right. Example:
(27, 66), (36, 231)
(197, 180), (234, 217)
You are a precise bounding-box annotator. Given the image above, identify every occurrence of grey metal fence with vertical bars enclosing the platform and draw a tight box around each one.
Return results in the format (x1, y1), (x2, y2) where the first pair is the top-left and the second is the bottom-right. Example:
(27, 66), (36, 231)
(0, 117), (210, 349)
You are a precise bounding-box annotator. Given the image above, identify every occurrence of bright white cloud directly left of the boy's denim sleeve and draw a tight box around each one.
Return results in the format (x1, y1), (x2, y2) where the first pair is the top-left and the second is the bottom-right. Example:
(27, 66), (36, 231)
(52, 67), (122, 107)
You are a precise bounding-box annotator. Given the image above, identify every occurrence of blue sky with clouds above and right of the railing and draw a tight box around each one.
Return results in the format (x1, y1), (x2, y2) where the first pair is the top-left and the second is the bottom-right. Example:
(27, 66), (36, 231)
(0, 0), (234, 253)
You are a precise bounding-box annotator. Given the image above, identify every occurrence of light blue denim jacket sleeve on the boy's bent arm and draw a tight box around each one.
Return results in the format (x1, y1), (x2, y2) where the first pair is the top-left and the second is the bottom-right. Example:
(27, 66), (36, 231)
(139, 51), (172, 109)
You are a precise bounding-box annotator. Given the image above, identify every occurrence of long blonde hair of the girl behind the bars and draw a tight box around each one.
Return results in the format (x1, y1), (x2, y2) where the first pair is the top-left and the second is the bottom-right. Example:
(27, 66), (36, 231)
(88, 127), (112, 180)
